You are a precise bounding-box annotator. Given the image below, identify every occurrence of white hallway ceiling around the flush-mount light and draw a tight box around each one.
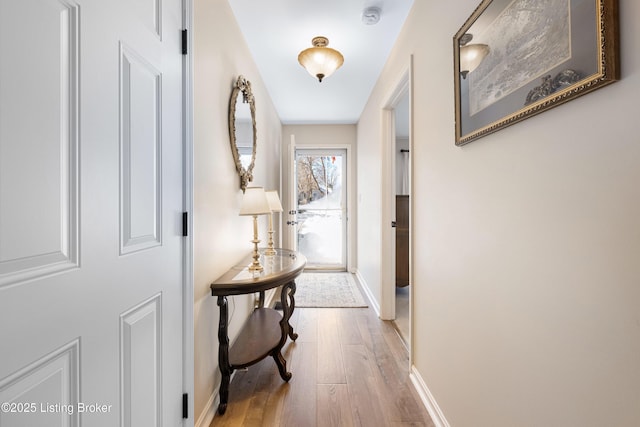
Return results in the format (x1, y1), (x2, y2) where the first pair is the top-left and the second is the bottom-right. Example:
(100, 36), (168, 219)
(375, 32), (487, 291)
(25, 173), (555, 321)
(229, 0), (413, 124)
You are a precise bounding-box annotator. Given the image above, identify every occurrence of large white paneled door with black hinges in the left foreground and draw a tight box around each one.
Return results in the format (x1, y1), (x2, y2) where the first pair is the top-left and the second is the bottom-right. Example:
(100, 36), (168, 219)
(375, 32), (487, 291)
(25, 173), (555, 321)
(0, 0), (185, 427)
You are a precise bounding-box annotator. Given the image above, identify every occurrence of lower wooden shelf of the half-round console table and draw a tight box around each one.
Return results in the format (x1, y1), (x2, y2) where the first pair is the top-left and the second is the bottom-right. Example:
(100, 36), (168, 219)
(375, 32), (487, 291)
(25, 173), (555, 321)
(229, 308), (282, 369)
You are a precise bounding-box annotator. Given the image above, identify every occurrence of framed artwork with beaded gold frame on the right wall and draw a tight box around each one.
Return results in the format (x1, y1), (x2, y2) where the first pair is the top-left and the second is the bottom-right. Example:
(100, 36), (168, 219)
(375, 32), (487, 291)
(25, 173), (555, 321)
(453, 0), (620, 145)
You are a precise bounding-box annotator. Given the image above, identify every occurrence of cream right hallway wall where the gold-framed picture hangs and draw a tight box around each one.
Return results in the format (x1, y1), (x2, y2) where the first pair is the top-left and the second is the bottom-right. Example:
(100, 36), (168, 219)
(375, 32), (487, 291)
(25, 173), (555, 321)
(358, 0), (640, 427)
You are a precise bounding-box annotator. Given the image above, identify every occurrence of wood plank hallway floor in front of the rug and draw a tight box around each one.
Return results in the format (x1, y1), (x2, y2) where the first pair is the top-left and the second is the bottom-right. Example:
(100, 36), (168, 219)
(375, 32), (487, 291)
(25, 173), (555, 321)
(211, 308), (434, 427)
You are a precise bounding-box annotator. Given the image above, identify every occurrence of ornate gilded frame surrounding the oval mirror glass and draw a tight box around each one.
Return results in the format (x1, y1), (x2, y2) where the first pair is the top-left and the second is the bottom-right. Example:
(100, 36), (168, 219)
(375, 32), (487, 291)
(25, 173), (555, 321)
(229, 76), (258, 193)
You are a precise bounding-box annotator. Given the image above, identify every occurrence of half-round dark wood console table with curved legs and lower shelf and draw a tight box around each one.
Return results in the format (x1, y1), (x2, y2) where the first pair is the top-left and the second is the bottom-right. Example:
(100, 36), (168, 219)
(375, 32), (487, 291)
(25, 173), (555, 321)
(211, 249), (307, 414)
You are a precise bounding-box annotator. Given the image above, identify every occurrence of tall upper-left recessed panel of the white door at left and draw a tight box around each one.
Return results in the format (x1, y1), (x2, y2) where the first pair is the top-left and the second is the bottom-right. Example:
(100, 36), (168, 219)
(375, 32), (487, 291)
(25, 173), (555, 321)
(0, 0), (79, 288)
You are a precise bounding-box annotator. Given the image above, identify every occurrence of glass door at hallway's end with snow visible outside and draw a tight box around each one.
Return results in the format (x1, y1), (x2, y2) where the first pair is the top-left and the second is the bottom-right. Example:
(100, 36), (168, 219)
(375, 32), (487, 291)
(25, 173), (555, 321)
(293, 149), (347, 270)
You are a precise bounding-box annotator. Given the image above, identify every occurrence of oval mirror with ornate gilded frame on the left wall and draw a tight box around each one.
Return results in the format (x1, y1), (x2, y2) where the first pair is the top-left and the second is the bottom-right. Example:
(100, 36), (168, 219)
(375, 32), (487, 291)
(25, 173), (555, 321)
(229, 76), (256, 192)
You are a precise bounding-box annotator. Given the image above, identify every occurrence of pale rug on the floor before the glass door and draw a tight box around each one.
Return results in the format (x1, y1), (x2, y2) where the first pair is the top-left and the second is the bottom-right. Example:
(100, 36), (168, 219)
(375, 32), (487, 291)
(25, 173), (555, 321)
(295, 273), (367, 307)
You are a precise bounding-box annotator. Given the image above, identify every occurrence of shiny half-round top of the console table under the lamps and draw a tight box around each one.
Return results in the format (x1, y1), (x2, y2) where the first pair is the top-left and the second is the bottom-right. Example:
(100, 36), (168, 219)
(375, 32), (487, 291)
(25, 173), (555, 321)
(211, 249), (307, 296)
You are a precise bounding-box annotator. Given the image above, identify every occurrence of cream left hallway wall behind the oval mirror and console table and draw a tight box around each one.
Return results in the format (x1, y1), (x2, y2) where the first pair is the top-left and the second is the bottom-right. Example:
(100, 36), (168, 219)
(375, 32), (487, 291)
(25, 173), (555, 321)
(194, 0), (282, 426)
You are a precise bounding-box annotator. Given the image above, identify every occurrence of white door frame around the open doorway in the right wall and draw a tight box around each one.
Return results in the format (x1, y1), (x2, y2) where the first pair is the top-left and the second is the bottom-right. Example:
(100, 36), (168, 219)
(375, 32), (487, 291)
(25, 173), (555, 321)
(380, 56), (414, 358)
